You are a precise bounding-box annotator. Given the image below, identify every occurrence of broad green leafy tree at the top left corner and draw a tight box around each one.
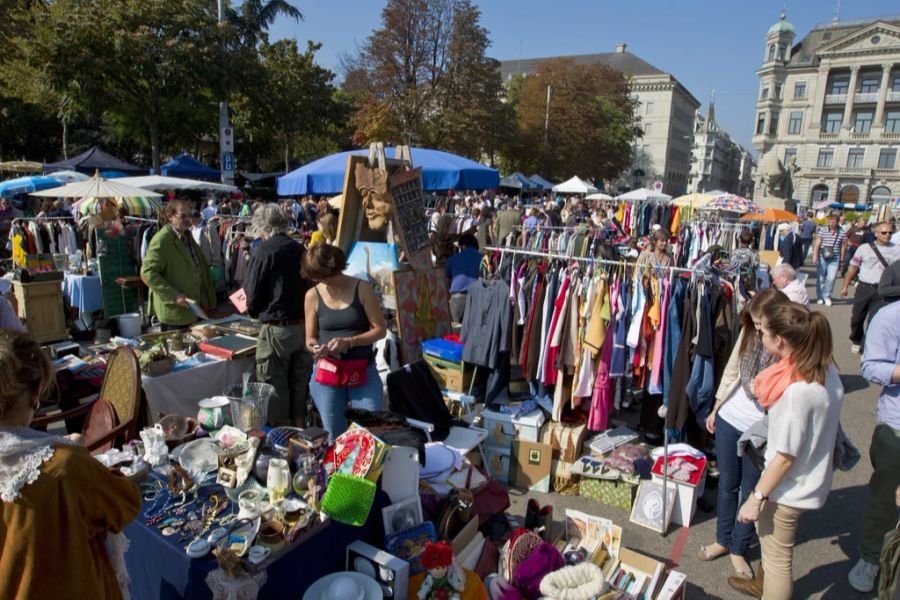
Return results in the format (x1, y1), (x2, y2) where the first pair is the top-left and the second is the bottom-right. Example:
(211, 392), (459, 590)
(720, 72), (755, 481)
(0, 0), (248, 169)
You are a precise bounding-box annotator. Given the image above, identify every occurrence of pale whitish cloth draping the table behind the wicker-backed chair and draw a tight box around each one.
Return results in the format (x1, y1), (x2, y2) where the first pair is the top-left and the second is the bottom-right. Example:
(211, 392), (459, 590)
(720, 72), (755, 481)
(141, 356), (256, 421)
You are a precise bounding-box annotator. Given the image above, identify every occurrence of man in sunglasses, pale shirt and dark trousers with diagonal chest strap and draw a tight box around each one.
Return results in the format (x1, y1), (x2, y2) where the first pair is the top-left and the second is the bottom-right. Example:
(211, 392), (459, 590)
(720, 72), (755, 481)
(841, 221), (900, 354)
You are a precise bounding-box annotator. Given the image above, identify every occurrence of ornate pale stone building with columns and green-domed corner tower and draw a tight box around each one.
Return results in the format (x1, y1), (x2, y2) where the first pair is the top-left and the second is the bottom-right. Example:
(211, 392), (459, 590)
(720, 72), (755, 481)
(753, 12), (900, 208)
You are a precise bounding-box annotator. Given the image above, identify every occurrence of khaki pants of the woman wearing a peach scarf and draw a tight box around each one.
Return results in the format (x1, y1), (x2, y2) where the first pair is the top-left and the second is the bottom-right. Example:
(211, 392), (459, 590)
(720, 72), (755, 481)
(756, 502), (803, 600)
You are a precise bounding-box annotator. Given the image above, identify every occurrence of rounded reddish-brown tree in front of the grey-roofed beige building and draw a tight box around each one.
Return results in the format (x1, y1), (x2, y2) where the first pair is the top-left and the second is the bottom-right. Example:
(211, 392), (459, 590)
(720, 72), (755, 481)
(508, 59), (635, 184)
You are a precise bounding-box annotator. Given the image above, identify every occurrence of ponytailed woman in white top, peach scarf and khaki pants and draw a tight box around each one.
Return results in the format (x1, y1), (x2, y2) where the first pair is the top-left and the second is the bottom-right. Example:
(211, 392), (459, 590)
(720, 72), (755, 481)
(728, 303), (844, 600)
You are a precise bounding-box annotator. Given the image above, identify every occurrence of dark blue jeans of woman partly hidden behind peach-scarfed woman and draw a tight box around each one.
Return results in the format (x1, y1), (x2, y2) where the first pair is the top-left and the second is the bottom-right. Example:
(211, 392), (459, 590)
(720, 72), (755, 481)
(716, 414), (760, 558)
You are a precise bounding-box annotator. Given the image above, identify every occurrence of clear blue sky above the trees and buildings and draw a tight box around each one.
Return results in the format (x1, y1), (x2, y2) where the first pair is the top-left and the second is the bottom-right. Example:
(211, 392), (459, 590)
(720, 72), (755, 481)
(270, 0), (900, 155)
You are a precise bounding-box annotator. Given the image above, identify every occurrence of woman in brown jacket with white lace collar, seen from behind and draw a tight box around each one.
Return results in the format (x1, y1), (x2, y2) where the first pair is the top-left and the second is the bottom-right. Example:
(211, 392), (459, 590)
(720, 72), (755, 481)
(0, 330), (141, 600)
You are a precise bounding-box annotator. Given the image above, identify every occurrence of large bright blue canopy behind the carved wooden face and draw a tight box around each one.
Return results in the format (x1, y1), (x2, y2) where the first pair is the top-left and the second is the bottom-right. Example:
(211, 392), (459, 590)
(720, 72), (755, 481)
(278, 148), (500, 196)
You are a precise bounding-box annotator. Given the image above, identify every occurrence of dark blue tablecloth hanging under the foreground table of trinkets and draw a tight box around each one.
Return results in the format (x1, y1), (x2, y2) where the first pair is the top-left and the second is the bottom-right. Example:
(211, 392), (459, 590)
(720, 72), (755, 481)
(125, 492), (390, 600)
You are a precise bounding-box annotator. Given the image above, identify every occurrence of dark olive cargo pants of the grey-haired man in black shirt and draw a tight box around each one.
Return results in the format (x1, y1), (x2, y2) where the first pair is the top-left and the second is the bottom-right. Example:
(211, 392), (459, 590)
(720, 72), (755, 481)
(256, 323), (312, 427)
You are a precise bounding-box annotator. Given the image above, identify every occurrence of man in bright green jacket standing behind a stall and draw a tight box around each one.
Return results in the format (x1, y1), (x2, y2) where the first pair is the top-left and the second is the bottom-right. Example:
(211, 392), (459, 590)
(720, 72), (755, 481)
(141, 200), (216, 330)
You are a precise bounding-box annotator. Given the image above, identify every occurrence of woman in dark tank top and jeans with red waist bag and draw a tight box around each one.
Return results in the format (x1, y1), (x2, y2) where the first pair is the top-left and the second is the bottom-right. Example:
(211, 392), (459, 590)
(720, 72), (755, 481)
(303, 244), (387, 440)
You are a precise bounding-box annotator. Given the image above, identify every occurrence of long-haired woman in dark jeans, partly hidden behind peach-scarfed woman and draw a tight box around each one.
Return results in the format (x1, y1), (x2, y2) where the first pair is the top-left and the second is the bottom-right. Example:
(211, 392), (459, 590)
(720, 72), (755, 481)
(698, 288), (790, 579)
